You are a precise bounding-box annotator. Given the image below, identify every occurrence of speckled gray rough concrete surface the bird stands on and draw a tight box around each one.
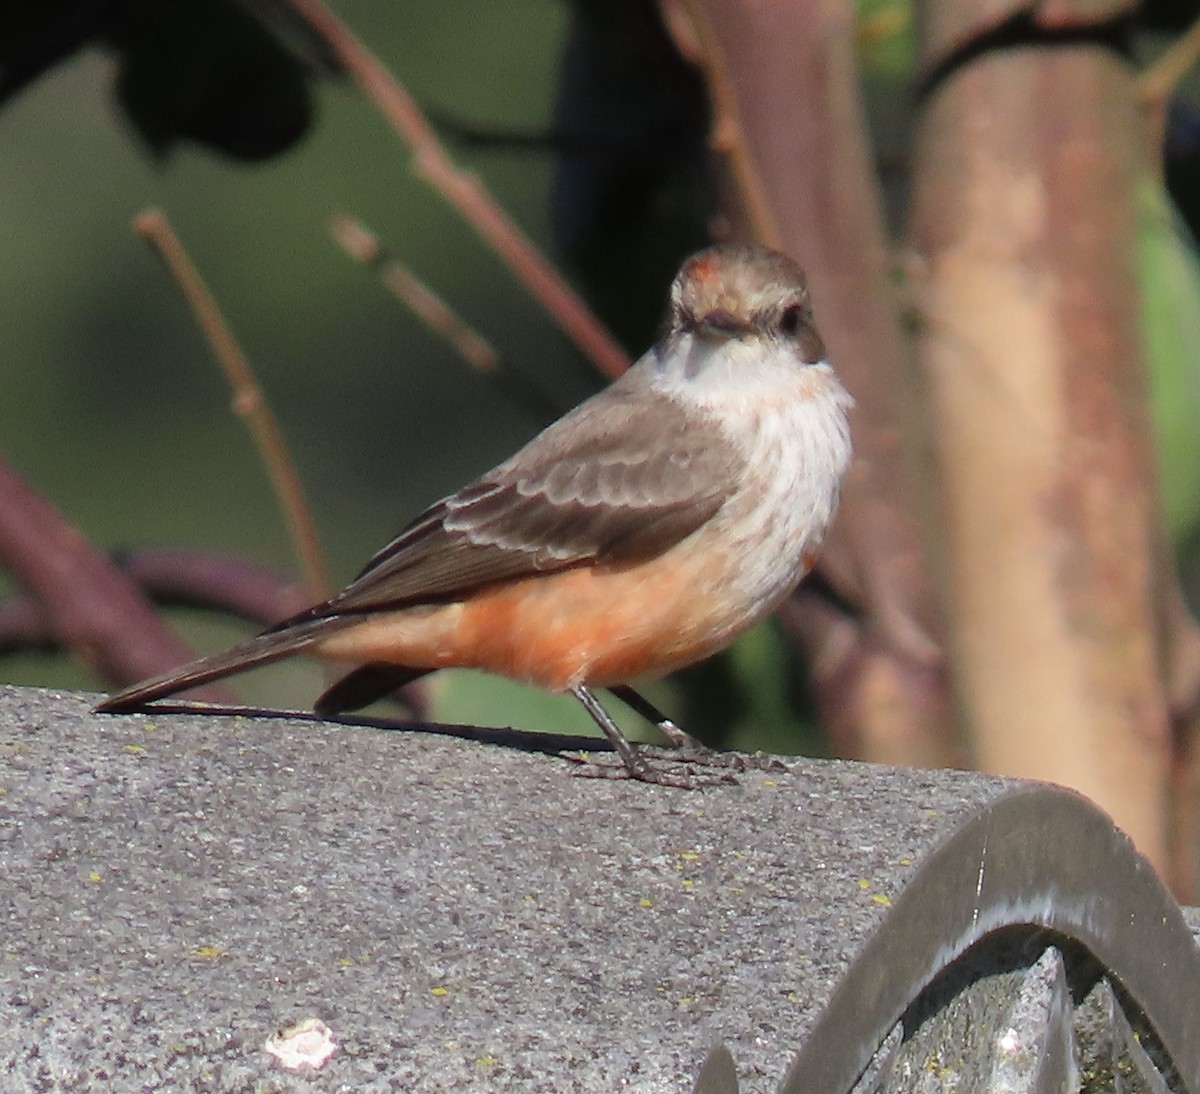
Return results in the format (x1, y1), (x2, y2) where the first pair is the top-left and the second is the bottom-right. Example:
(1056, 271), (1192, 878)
(0, 687), (1190, 1092)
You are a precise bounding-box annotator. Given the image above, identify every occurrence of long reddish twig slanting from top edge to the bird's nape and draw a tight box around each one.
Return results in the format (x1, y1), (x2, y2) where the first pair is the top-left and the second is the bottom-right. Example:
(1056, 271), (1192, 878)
(282, 0), (630, 378)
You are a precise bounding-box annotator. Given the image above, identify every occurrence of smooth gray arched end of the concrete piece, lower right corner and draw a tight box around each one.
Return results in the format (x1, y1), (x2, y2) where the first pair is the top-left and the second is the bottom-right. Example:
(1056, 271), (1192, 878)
(784, 786), (1200, 1094)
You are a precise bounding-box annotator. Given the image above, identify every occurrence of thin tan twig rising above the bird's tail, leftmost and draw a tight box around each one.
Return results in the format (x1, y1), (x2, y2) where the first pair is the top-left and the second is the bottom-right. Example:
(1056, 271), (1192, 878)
(133, 209), (329, 600)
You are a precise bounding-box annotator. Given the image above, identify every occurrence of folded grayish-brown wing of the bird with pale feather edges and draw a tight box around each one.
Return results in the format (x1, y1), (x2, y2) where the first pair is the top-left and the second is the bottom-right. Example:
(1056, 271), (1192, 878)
(310, 374), (744, 618)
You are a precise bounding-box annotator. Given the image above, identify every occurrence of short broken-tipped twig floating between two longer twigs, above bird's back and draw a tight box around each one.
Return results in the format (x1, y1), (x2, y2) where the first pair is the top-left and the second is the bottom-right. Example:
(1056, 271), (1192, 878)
(330, 214), (562, 421)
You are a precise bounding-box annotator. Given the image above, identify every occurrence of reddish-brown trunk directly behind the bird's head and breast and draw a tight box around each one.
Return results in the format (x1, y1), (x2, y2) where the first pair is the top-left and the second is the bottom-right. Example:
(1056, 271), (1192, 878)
(689, 0), (960, 765)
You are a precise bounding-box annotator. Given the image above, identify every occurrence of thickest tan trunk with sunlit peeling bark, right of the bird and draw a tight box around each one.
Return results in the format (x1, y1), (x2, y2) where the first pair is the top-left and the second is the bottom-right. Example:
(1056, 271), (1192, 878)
(911, 29), (1174, 877)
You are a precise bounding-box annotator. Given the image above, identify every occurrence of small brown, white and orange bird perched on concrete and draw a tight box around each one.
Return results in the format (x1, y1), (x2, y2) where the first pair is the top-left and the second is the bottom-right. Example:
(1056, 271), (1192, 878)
(96, 244), (853, 786)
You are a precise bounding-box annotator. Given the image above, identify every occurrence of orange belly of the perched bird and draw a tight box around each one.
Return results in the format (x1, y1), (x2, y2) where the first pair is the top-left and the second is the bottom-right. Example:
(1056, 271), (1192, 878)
(314, 539), (757, 691)
